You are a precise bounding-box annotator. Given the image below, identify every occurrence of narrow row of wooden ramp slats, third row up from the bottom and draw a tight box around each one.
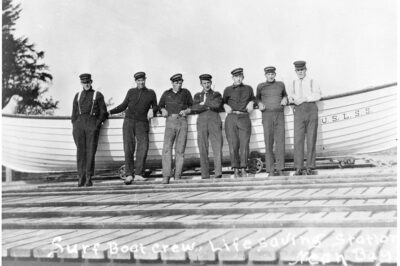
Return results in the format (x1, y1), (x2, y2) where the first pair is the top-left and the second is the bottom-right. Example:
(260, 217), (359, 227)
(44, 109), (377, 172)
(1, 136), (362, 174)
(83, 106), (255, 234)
(2, 187), (396, 206)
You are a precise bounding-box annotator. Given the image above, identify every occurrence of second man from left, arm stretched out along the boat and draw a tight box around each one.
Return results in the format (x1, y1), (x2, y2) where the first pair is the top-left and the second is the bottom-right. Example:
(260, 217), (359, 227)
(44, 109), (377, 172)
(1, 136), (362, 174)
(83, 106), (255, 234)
(110, 72), (158, 185)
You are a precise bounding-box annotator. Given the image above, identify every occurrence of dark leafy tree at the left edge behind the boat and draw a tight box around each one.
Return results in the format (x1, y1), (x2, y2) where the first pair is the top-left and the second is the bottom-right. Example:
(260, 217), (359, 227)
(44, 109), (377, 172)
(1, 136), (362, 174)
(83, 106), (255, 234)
(2, 0), (58, 114)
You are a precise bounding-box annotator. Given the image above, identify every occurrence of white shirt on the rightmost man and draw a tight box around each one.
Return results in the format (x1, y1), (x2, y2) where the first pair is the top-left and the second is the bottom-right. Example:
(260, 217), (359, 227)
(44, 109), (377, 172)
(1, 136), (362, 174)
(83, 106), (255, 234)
(287, 76), (321, 102)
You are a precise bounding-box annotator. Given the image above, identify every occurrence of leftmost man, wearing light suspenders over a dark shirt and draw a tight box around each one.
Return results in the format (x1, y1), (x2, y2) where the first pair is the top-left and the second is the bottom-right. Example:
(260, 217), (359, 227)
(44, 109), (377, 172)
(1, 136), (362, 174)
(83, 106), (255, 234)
(71, 74), (107, 187)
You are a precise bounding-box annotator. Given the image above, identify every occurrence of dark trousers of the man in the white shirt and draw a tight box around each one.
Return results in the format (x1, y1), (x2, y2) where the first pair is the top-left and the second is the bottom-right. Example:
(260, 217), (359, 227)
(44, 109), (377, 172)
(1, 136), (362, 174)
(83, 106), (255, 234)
(294, 102), (318, 169)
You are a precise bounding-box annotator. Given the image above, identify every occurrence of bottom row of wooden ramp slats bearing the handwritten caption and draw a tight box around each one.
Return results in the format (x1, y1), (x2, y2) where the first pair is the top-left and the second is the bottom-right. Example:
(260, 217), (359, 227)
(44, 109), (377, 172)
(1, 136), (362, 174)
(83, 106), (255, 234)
(2, 227), (397, 264)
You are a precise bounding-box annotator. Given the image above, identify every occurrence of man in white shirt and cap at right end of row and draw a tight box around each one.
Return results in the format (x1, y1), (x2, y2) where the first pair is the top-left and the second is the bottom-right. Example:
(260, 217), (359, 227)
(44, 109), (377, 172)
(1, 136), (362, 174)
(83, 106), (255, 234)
(288, 61), (321, 175)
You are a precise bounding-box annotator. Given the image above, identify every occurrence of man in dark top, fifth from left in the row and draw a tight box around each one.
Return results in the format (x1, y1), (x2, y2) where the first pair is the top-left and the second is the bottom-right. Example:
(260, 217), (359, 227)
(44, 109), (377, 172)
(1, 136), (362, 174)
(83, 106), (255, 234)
(222, 68), (255, 178)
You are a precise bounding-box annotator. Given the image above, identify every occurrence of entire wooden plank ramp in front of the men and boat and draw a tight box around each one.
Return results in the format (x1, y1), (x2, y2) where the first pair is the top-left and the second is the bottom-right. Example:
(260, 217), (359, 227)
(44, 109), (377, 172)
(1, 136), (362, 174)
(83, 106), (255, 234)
(2, 168), (397, 265)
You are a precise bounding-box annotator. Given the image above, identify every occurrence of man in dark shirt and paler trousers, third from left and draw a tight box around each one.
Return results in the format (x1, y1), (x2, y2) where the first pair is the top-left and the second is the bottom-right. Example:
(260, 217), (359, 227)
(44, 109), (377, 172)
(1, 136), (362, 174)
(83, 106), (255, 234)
(159, 74), (193, 184)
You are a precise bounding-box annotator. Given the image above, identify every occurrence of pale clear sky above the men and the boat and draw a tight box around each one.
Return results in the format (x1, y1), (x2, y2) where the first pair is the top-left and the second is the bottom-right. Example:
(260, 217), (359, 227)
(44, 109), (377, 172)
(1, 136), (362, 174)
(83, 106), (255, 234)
(15, 0), (397, 115)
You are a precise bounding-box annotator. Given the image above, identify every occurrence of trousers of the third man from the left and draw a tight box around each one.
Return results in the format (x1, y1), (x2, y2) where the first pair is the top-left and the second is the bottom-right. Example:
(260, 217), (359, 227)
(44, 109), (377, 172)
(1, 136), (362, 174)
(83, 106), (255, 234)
(162, 116), (188, 179)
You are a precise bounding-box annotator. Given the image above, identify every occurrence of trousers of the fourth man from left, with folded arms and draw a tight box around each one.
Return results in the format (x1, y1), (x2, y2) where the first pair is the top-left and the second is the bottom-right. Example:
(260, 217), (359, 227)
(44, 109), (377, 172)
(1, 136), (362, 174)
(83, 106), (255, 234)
(197, 111), (223, 178)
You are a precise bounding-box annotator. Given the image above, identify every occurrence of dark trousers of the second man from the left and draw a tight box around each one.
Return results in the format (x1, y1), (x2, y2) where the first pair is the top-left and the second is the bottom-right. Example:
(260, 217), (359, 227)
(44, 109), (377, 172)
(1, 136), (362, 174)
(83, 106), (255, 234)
(122, 118), (149, 176)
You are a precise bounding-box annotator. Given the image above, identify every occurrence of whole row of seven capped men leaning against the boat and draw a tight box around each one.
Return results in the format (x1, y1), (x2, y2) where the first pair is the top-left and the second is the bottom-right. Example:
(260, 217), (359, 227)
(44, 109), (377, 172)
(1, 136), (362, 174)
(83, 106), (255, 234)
(71, 61), (321, 186)
